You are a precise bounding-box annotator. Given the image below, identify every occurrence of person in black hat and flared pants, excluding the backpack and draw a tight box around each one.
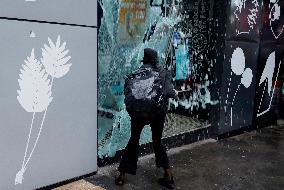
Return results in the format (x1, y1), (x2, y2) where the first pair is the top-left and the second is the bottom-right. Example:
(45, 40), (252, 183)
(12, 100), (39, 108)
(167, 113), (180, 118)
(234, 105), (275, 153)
(115, 48), (176, 189)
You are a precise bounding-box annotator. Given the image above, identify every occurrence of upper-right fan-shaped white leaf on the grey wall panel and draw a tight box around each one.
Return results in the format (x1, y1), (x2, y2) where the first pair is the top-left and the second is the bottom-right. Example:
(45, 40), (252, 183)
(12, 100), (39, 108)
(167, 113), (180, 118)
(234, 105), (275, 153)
(41, 36), (72, 78)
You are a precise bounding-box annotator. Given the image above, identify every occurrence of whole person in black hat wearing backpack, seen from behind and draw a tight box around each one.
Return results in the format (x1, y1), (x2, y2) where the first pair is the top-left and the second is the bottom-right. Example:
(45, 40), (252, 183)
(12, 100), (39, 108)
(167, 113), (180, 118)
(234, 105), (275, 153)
(115, 48), (175, 189)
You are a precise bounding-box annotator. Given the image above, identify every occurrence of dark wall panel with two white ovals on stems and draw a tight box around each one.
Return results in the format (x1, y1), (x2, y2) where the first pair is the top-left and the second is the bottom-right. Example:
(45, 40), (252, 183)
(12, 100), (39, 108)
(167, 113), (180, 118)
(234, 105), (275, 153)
(219, 41), (259, 134)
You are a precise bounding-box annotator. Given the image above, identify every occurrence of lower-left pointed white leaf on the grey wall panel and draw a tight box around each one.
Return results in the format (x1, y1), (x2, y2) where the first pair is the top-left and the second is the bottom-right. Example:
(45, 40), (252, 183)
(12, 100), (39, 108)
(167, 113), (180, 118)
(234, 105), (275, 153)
(17, 49), (53, 112)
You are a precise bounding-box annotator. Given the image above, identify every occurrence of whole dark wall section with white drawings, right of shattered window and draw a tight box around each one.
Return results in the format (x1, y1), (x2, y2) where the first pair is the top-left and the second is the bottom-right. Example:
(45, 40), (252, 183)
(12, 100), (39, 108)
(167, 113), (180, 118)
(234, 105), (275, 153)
(216, 0), (284, 134)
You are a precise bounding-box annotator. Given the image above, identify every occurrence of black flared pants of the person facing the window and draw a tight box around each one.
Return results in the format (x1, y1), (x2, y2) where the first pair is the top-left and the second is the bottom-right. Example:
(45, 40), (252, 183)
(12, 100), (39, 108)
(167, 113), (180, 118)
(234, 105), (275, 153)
(118, 114), (170, 175)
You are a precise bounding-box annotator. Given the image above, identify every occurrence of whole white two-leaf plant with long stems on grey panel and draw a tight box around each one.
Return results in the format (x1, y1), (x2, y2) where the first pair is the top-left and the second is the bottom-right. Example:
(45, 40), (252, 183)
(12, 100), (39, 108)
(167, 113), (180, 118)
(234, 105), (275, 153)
(15, 36), (72, 185)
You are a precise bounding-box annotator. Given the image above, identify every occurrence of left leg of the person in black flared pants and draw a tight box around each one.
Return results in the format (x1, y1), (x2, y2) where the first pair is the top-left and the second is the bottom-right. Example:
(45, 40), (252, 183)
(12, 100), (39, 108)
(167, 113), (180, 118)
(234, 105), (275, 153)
(118, 117), (144, 175)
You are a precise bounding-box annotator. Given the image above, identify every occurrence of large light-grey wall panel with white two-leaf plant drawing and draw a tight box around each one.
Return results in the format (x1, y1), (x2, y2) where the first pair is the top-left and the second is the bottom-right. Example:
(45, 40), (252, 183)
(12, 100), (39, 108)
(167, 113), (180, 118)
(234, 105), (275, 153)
(0, 20), (97, 190)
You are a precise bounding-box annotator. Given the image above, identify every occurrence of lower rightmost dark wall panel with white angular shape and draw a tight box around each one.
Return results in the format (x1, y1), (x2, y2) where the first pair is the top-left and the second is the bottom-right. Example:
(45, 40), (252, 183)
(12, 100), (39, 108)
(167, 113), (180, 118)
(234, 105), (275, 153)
(255, 42), (284, 125)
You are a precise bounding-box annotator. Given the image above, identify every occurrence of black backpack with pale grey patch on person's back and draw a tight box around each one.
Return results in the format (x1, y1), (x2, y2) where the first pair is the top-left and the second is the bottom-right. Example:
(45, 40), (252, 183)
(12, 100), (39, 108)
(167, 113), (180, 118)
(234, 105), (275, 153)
(124, 67), (164, 113)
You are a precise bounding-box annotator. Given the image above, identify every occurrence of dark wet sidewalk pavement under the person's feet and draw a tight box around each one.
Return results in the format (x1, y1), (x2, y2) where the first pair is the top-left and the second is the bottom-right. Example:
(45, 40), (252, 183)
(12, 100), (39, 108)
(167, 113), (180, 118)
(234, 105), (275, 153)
(56, 124), (284, 190)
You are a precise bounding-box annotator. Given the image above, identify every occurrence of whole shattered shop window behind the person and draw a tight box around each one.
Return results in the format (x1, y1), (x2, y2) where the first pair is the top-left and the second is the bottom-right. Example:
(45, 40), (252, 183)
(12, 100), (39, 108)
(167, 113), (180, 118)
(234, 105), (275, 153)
(98, 0), (220, 158)
